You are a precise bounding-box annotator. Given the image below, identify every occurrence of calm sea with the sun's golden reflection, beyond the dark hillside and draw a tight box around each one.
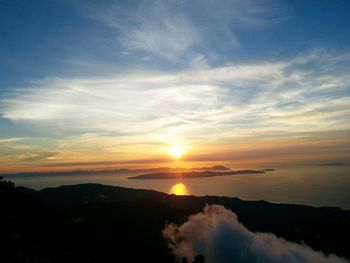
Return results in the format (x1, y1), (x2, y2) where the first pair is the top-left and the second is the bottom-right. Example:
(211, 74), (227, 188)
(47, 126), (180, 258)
(5, 166), (350, 209)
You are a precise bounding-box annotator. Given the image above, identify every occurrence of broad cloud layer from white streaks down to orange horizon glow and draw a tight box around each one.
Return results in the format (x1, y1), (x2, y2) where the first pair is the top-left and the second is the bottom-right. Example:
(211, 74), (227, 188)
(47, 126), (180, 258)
(0, 51), (350, 169)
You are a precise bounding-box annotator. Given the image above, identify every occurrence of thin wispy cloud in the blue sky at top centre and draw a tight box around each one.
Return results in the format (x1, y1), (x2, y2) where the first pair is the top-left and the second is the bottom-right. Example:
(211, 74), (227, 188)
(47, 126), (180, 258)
(86, 0), (289, 65)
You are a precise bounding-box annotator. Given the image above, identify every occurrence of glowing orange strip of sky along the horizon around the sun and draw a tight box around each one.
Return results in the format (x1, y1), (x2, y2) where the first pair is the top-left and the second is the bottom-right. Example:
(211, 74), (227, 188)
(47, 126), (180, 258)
(0, 134), (350, 173)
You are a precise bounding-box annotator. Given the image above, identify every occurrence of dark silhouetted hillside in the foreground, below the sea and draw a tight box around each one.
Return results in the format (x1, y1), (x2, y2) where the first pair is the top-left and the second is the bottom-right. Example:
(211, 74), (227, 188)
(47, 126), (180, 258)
(0, 181), (350, 263)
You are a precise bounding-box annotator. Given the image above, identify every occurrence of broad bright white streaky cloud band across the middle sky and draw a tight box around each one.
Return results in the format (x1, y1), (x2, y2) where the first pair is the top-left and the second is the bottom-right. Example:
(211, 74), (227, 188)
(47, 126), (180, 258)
(0, 50), (350, 144)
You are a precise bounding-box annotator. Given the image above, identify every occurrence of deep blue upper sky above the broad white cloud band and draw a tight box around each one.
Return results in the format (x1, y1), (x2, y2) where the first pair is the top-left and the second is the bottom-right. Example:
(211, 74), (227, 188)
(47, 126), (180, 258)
(0, 0), (350, 85)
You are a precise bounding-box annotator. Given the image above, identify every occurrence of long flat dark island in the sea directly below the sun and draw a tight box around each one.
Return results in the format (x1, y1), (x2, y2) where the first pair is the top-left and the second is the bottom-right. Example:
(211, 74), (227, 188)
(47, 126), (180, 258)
(128, 169), (266, 180)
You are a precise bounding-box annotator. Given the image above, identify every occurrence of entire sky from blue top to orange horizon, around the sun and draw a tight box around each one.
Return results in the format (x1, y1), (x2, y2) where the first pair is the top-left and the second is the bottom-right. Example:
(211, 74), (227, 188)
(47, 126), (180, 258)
(0, 0), (350, 172)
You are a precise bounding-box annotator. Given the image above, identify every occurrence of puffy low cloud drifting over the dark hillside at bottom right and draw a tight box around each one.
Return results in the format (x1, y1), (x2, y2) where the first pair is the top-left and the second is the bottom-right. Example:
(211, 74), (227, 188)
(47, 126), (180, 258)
(163, 205), (348, 263)
